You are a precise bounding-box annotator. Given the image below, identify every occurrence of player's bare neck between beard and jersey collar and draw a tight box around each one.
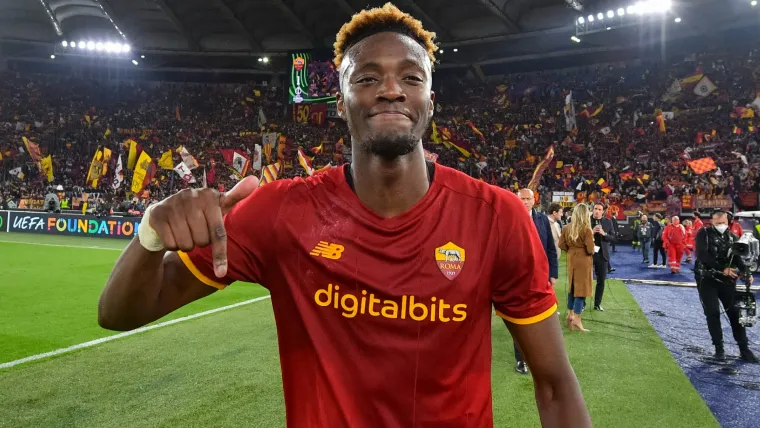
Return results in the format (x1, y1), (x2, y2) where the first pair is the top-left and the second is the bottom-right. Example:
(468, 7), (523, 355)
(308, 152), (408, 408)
(351, 144), (430, 218)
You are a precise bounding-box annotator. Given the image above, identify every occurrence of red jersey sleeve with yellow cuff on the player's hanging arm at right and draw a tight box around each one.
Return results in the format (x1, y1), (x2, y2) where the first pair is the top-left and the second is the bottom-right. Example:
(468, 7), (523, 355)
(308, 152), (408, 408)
(491, 191), (557, 324)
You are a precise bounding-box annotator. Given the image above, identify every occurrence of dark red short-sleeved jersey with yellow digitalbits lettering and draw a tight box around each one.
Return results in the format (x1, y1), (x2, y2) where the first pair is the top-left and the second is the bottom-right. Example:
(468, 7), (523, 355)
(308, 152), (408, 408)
(180, 165), (557, 428)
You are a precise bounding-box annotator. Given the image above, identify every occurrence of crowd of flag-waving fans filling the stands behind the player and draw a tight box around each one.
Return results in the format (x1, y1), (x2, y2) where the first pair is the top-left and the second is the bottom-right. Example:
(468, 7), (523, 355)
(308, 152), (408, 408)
(0, 49), (760, 217)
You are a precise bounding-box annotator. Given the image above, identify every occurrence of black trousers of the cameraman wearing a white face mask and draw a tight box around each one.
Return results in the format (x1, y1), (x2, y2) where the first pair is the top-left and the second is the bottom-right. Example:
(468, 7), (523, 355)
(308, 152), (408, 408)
(697, 279), (748, 347)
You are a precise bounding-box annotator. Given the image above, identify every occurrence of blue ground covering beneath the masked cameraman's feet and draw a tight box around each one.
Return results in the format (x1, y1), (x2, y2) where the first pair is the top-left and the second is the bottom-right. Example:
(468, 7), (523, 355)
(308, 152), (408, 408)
(628, 284), (760, 428)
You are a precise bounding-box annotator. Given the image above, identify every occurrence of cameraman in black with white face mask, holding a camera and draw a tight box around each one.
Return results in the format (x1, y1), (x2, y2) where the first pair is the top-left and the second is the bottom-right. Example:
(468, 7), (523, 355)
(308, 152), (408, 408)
(694, 211), (760, 363)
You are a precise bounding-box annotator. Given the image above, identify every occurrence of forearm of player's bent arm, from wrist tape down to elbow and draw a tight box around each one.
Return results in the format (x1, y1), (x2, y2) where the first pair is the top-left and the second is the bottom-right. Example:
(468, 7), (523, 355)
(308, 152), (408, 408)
(98, 239), (165, 330)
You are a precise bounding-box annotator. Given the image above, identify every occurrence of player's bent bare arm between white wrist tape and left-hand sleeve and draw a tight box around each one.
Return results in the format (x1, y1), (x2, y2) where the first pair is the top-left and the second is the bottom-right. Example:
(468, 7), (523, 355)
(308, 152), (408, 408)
(98, 239), (216, 331)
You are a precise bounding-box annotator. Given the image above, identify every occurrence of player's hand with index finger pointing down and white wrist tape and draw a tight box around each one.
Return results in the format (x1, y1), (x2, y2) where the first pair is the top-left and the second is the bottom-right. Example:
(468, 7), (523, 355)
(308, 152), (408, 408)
(139, 176), (259, 278)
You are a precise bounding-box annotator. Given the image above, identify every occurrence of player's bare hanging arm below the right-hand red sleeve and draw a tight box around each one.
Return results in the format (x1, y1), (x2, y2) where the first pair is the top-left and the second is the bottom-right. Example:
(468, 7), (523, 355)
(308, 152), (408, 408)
(504, 315), (592, 428)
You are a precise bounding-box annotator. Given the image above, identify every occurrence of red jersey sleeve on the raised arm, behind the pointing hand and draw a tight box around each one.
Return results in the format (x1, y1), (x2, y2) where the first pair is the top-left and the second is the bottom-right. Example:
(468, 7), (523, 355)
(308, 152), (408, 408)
(177, 180), (291, 290)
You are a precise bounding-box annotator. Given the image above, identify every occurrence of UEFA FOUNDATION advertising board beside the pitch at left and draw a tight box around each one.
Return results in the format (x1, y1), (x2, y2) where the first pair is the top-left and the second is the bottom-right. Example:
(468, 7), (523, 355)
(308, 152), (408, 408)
(0, 211), (141, 239)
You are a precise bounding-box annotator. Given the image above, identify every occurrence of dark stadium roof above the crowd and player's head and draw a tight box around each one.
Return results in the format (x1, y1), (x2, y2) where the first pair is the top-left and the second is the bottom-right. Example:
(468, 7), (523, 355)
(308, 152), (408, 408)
(0, 0), (760, 74)
